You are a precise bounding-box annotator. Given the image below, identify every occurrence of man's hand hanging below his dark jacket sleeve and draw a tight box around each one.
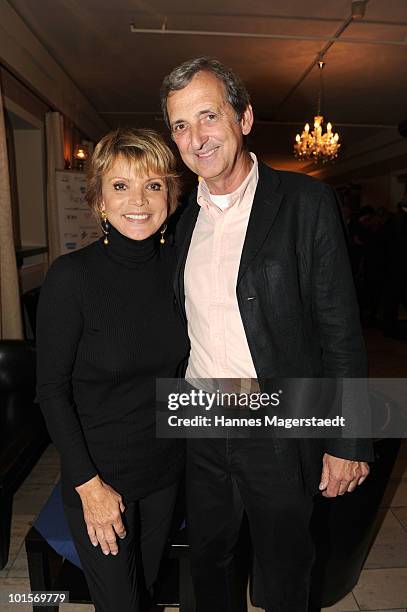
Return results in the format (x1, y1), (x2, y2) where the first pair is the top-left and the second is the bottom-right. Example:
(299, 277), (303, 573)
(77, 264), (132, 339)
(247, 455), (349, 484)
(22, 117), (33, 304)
(319, 453), (370, 497)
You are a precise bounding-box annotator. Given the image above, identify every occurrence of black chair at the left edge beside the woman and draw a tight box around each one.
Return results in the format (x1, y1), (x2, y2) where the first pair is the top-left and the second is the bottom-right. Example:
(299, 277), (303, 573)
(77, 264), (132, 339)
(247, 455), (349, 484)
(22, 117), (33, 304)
(0, 340), (49, 569)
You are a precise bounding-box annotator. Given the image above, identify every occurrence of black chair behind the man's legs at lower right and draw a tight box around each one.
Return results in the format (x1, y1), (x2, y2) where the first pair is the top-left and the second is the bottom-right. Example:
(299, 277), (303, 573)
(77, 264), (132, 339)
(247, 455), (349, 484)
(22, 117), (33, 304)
(250, 438), (400, 612)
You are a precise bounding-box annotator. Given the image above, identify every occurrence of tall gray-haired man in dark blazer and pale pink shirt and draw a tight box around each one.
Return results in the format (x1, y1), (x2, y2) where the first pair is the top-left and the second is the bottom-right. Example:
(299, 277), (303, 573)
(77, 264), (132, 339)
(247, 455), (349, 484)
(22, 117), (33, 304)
(161, 58), (372, 612)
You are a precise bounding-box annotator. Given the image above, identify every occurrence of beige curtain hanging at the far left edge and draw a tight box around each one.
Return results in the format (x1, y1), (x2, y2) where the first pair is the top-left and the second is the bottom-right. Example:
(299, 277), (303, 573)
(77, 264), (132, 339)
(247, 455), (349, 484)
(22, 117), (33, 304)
(0, 76), (23, 339)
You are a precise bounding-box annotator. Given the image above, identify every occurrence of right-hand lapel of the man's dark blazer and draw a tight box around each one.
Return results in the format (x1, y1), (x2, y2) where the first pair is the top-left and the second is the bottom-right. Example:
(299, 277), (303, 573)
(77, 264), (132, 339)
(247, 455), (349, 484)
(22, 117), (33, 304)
(237, 163), (283, 284)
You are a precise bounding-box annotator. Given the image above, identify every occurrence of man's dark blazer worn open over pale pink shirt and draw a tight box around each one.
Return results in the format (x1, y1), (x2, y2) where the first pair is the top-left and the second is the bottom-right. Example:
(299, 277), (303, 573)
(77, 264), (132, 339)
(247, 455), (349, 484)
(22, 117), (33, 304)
(175, 163), (373, 488)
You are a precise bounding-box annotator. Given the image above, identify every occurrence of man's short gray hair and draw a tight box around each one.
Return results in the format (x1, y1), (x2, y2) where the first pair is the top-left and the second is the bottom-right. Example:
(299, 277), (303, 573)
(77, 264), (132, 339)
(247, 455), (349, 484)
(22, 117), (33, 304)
(160, 56), (250, 127)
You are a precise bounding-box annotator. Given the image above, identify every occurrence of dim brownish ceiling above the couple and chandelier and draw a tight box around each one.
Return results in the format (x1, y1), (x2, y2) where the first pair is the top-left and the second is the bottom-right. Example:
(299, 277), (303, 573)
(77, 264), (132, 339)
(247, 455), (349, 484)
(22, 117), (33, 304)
(9, 0), (407, 173)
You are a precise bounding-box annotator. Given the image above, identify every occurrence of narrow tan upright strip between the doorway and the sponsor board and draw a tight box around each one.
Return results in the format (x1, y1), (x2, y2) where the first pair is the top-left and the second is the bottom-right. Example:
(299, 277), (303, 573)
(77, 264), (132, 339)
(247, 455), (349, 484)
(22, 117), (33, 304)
(45, 112), (65, 264)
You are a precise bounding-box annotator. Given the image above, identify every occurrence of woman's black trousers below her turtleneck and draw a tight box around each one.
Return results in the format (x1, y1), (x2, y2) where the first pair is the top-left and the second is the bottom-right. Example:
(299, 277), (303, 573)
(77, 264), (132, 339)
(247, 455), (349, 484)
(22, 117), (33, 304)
(64, 484), (178, 612)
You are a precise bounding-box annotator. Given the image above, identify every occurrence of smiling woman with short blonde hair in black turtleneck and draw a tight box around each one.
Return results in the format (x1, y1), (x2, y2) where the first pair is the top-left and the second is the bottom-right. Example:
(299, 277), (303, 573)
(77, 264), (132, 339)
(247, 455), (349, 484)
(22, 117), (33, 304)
(37, 129), (188, 612)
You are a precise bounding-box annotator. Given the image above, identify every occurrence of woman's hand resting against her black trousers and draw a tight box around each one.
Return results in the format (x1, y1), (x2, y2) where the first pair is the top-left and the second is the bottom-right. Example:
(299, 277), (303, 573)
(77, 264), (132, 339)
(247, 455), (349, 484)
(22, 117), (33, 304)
(76, 476), (126, 555)
